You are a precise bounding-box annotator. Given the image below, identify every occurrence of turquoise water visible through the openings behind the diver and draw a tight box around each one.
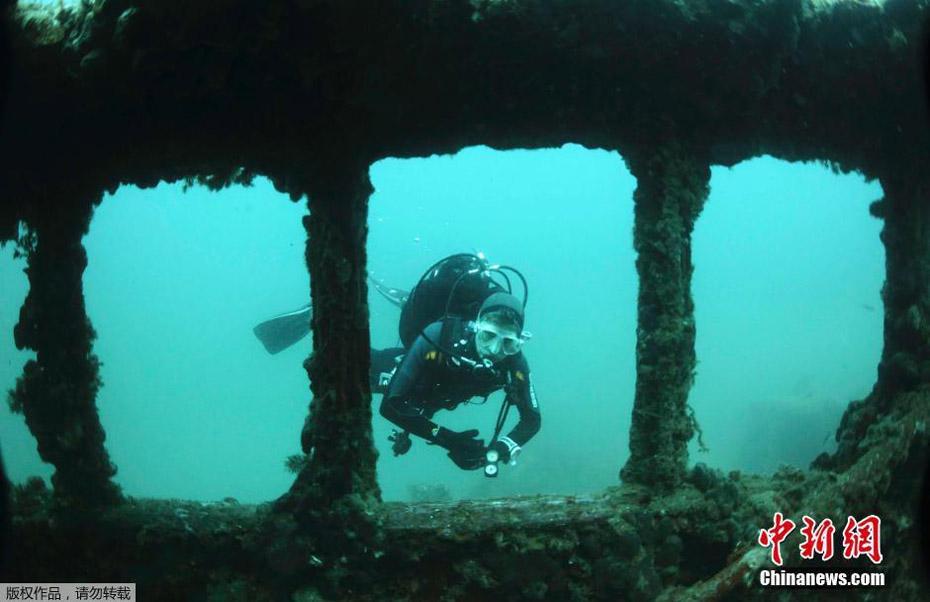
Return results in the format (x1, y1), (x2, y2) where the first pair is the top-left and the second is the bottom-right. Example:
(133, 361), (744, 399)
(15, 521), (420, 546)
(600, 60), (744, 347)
(0, 145), (884, 502)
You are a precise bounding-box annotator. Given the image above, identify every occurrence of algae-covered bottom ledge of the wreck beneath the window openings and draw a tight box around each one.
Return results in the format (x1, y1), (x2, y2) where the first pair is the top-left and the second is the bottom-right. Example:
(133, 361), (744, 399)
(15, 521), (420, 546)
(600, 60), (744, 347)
(5, 390), (930, 602)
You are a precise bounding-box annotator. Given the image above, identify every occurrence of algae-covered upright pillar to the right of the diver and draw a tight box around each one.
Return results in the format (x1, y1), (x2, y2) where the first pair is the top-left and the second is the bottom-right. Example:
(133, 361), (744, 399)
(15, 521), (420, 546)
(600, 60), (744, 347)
(620, 143), (710, 488)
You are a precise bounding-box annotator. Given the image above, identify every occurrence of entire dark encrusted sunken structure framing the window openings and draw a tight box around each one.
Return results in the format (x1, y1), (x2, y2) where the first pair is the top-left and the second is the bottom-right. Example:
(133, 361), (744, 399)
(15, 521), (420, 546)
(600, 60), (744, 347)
(0, 0), (930, 600)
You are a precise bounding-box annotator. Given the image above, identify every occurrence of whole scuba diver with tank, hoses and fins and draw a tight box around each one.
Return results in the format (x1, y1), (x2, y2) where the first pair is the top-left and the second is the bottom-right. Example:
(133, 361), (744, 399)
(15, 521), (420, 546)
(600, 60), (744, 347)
(254, 253), (541, 477)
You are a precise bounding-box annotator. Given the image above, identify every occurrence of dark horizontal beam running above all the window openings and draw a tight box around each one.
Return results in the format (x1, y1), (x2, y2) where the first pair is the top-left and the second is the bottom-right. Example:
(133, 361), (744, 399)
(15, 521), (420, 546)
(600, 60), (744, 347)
(0, 0), (930, 209)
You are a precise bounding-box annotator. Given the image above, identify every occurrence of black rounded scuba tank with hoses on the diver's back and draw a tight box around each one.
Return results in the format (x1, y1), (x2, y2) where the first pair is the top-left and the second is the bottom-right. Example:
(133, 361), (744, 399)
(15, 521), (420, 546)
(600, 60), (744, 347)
(399, 253), (528, 349)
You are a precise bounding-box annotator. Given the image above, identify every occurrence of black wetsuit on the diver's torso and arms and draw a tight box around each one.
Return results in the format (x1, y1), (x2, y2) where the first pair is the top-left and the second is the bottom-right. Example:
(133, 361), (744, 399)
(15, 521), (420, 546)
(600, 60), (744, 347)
(373, 322), (542, 447)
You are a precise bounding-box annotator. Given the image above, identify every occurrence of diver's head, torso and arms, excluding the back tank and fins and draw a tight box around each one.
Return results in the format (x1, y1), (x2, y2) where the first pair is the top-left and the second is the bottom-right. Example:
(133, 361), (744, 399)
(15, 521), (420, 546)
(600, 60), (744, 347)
(372, 292), (541, 468)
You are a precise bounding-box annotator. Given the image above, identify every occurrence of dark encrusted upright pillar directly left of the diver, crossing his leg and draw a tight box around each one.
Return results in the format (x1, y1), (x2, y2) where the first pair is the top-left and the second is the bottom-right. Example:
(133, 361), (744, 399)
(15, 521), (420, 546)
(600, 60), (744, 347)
(276, 164), (380, 528)
